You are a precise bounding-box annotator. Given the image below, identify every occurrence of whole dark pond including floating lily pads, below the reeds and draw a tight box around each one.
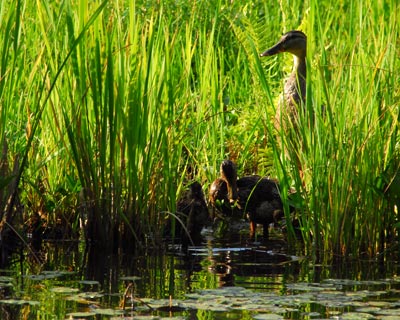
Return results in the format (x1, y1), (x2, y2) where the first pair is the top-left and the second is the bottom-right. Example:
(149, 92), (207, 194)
(0, 225), (400, 319)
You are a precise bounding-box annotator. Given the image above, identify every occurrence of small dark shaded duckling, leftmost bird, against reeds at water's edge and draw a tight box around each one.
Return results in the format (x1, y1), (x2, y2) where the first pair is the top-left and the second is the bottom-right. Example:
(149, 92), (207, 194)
(175, 181), (208, 246)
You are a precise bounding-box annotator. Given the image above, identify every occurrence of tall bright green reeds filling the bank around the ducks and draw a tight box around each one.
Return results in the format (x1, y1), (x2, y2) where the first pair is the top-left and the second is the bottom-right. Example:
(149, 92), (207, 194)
(0, 0), (399, 254)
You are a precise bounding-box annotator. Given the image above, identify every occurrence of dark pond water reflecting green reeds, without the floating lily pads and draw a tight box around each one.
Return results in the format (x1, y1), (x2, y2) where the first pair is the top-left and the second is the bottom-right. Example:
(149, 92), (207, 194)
(0, 229), (400, 319)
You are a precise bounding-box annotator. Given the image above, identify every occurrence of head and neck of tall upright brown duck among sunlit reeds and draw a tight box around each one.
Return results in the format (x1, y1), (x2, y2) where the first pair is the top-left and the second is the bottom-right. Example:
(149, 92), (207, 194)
(260, 30), (307, 130)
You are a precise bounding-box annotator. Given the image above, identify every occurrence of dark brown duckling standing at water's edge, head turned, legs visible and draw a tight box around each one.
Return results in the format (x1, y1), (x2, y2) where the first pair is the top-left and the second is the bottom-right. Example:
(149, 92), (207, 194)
(211, 160), (283, 239)
